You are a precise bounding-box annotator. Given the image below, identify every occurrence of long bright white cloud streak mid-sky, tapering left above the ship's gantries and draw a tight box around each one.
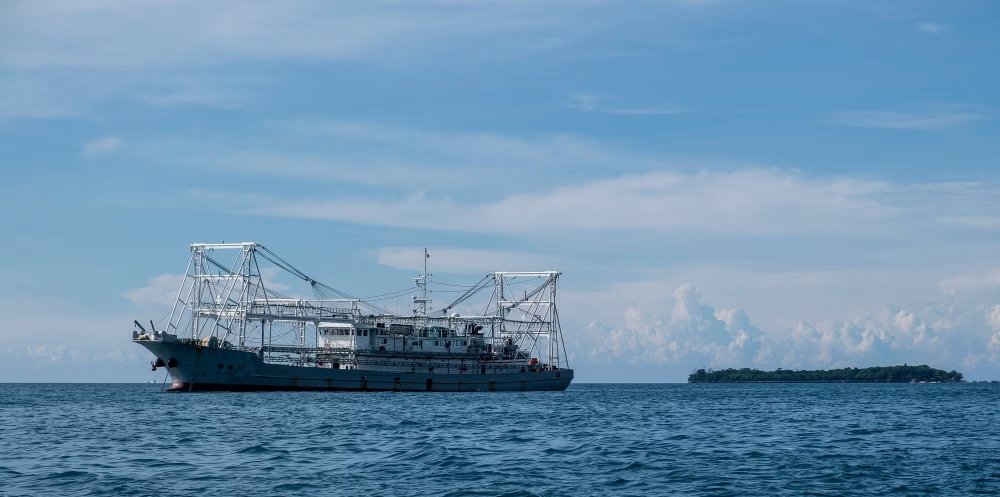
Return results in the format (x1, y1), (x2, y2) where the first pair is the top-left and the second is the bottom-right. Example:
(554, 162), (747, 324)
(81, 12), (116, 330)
(236, 169), (900, 235)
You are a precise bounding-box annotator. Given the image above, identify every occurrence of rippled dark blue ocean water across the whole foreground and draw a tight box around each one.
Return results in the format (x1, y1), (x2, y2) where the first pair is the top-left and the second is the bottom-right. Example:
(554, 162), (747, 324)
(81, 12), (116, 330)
(0, 384), (1000, 496)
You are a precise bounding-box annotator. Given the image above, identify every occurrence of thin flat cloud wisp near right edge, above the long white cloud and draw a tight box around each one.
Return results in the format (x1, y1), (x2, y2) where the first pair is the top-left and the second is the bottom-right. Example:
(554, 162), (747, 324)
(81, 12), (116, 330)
(832, 110), (989, 131)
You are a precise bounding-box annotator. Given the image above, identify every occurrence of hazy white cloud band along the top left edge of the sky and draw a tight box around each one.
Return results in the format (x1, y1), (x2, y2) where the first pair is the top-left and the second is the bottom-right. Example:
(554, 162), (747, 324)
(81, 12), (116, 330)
(0, 0), (616, 67)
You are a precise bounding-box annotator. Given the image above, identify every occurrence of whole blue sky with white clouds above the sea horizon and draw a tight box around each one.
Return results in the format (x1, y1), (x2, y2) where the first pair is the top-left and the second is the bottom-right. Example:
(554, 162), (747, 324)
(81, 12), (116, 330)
(0, 0), (1000, 382)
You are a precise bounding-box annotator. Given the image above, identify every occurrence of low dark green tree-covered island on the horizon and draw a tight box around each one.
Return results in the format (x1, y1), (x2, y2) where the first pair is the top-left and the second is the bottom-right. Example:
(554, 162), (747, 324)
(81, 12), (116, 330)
(688, 364), (962, 383)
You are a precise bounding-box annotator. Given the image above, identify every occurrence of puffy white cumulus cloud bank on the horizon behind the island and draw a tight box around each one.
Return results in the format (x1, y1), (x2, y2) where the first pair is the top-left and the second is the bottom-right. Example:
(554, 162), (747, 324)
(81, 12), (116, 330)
(583, 285), (1000, 378)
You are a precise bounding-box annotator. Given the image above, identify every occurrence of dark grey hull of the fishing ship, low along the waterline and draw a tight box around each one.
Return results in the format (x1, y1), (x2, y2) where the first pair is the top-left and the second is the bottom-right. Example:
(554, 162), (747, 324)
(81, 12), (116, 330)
(136, 340), (573, 392)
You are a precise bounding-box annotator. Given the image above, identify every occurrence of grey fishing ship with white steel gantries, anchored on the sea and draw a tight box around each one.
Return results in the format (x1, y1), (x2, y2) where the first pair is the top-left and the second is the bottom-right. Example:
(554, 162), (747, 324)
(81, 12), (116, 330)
(132, 242), (573, 392)
